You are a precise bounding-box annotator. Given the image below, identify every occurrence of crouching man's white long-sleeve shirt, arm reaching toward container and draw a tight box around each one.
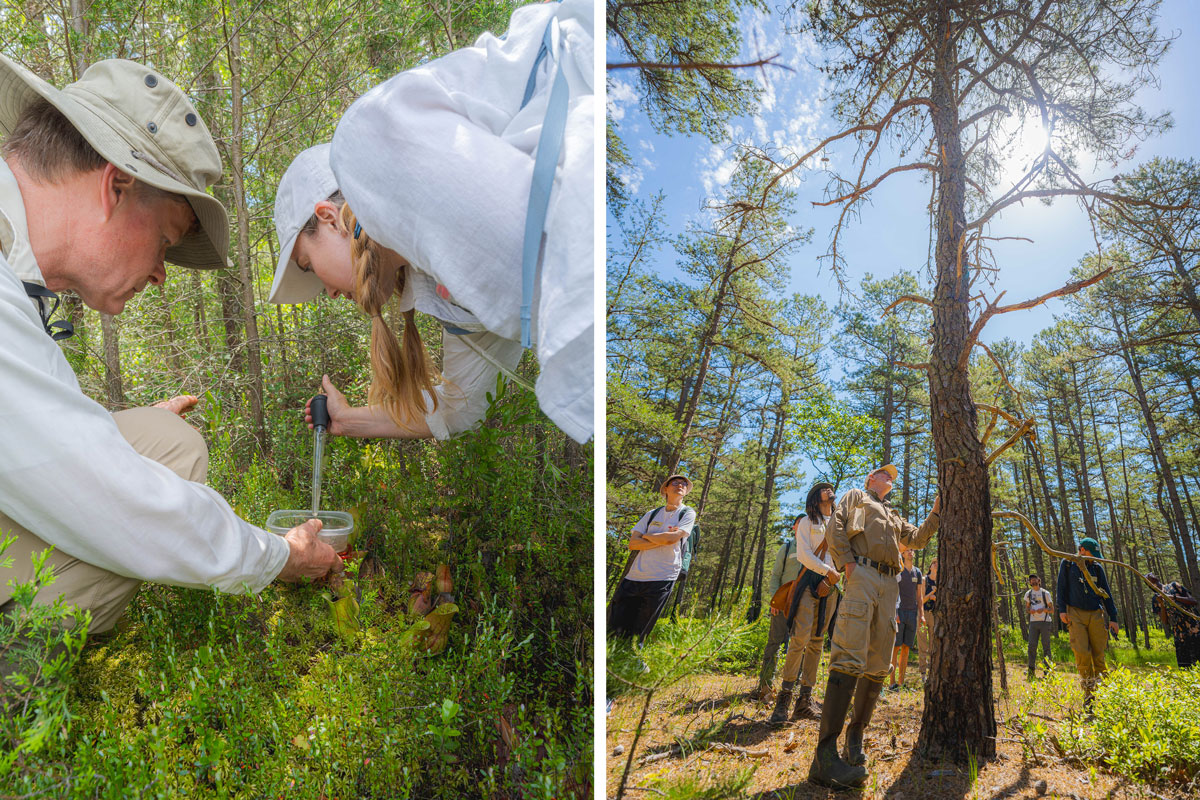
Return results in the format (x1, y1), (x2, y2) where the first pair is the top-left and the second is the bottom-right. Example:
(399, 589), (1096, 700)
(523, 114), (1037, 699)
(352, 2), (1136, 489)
(0, 161), (288, 593)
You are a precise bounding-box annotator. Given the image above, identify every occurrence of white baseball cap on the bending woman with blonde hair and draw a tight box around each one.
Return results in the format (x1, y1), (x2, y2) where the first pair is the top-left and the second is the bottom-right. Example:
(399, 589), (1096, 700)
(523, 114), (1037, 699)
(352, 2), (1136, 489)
(268, 142), (337, 303)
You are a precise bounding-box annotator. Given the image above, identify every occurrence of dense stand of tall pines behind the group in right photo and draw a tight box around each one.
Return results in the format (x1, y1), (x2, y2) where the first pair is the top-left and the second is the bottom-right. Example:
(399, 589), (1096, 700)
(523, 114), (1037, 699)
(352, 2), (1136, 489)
(606, 2), (1200, 666)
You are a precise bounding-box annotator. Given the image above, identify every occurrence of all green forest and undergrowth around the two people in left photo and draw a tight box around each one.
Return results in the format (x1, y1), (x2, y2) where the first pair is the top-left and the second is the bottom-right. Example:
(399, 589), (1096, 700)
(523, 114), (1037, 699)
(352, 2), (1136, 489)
(0, 0), (593, 798)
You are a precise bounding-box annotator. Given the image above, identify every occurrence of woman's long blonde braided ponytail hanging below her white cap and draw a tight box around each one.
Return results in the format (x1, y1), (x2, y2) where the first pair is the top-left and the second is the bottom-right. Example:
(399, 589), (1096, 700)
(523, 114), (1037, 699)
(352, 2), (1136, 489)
(338, 205), (438, 427)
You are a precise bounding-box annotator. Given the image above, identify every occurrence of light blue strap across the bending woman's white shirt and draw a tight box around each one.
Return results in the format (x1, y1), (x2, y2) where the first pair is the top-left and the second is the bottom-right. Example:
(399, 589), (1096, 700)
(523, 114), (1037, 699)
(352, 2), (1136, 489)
(521, 8), (568, 348)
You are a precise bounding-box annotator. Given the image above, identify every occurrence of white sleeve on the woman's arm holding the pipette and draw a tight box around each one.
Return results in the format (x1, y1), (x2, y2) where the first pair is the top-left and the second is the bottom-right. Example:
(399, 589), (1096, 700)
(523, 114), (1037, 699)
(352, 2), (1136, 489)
(425, 332), (523, 439)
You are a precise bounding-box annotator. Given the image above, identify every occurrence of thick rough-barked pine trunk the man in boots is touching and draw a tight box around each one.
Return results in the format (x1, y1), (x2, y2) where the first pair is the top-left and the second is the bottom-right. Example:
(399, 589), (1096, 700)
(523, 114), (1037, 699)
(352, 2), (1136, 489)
(917, 0), (996, 762)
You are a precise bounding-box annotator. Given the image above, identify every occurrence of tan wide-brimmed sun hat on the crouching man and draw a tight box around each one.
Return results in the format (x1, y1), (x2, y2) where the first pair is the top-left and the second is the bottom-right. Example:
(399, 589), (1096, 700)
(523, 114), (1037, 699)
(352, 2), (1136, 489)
(0, 55), (229, 270)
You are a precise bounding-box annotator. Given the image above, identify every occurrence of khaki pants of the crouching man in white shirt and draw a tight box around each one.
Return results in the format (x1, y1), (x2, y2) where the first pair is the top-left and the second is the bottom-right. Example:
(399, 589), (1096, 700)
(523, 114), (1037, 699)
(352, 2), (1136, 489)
(0, 408), (209, 633)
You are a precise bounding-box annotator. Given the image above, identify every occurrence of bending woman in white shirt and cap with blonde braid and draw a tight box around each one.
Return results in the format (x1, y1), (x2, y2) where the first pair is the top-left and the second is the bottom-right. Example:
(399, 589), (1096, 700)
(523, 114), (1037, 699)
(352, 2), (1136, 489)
(270, 0), (594, 443)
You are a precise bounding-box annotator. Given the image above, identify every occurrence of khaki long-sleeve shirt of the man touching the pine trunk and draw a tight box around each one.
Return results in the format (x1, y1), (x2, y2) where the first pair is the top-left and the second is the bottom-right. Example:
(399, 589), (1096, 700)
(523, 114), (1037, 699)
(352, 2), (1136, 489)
(827, 489), (938, 570)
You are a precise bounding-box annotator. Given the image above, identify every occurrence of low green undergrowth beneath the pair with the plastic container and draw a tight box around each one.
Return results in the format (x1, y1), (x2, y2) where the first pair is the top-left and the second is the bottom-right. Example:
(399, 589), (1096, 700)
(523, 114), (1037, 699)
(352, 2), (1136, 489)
(0, 381), (593, 799)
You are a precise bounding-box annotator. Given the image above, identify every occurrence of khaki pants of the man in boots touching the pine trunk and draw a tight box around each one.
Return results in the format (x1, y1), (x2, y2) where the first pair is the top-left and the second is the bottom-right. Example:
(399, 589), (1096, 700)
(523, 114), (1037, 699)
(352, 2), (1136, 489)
(829, 564), (900, 682)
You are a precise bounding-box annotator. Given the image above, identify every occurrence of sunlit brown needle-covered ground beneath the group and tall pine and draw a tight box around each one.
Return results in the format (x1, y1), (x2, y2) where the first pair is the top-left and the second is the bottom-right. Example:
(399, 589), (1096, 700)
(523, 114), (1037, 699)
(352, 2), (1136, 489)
(607, 663), (1195, 800)
